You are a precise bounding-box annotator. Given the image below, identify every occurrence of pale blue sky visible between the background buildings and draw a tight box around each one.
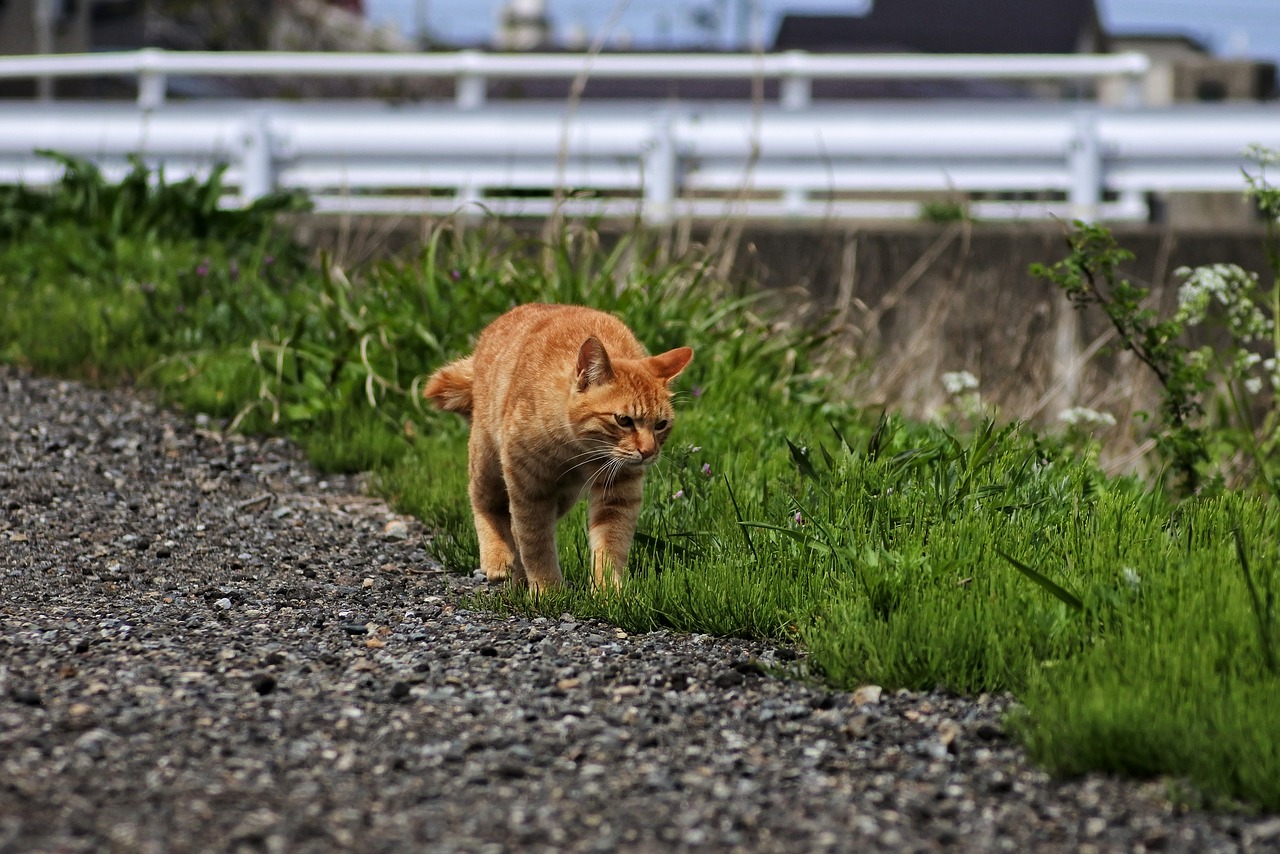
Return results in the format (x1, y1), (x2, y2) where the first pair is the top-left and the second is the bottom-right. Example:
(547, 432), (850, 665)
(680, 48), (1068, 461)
(365, 0), (1280, 67)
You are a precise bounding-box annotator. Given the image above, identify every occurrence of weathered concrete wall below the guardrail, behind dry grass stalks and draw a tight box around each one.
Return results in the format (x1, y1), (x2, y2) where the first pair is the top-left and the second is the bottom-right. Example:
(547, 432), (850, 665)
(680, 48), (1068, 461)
(735, 224), (1267, 431)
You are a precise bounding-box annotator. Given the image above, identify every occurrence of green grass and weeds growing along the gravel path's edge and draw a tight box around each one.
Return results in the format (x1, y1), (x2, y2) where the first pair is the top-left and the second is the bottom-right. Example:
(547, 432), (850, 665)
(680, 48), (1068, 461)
(0, 153), (1280, 810)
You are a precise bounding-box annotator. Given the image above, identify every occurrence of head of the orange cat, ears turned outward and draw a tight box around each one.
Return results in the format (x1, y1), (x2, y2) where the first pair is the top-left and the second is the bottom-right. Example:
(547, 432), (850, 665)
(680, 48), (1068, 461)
(568, 337), (694, 466)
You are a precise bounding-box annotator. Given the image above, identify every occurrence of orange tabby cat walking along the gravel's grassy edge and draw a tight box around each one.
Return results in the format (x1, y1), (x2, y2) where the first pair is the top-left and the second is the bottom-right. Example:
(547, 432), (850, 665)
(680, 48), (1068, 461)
(425, 305), (694, 592)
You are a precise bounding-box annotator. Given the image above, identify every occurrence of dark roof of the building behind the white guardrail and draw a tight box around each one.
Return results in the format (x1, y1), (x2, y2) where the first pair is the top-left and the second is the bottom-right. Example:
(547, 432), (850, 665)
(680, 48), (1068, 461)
(773, 0), (1101, 54)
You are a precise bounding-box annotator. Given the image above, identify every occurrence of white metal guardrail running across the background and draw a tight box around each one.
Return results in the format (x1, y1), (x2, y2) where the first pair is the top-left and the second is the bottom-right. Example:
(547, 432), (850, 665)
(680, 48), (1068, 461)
(0, 51), (1280, 223)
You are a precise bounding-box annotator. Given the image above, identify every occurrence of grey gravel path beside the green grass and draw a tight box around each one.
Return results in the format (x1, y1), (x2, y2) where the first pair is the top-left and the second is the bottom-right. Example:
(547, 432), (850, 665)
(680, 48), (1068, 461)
(0, 367), (1280, 851)
